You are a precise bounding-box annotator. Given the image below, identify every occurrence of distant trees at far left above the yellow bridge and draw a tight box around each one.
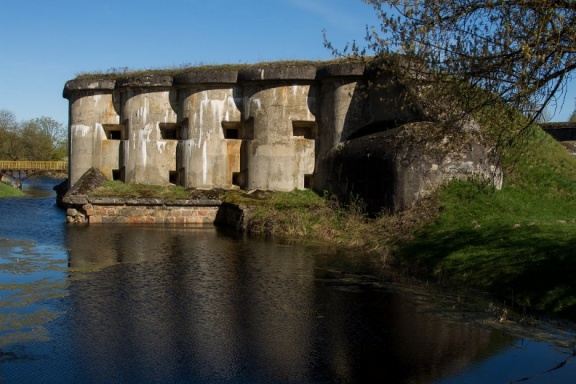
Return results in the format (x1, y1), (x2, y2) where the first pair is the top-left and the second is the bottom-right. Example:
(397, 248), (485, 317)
(0, 109), (68, 161)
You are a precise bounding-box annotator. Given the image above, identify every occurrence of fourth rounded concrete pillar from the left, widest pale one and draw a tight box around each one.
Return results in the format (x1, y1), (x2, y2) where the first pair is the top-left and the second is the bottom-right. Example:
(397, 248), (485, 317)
(238, 66), (318, 191)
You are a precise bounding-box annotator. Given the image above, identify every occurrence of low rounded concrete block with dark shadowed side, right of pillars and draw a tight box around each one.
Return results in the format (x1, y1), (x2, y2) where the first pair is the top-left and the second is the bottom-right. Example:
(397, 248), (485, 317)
(331, 123), (502, 214)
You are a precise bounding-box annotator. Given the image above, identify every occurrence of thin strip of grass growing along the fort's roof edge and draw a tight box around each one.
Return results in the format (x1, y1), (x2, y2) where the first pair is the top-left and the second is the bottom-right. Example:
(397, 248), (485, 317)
(76, 59), (342, 80)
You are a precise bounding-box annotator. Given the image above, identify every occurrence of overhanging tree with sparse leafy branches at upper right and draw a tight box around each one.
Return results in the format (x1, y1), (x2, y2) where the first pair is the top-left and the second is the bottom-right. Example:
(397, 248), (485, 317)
(325, 0), (576, 140)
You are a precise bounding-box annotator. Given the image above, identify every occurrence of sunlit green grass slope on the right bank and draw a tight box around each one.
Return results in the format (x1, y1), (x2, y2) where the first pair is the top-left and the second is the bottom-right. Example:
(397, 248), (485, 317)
(396, 129), (576, 317)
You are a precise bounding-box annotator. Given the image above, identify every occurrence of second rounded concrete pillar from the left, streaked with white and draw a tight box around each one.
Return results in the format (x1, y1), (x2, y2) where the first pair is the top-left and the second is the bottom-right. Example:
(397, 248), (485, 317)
(116, 75), (178, 185)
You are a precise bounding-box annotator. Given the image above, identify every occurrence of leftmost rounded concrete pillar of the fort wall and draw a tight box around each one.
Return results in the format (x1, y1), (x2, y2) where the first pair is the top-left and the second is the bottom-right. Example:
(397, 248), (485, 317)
(63, 79), (120, 187)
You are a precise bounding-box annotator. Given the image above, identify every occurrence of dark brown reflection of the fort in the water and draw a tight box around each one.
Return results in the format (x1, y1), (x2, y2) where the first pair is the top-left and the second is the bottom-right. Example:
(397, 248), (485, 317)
(68, 226), (509, 382)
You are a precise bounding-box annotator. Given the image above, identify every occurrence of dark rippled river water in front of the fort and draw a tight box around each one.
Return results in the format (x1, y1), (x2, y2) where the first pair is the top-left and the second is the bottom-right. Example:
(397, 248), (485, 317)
(0, 179), (576, 384)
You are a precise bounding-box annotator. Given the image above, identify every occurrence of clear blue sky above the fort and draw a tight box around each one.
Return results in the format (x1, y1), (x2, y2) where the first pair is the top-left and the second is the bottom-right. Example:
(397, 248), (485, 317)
(0, 0), (576, 124)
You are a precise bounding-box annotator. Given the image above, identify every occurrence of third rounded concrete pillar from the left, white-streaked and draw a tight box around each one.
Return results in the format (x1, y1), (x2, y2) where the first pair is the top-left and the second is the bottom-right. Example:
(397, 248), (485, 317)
(174, 70), (242, 188)
